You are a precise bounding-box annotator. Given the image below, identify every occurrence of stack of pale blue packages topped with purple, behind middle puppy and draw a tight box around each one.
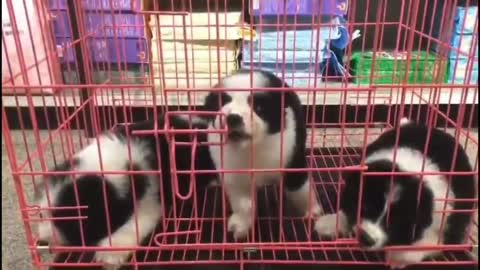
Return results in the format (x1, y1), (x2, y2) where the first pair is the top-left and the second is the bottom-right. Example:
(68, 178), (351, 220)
(241, 0), (349, 87)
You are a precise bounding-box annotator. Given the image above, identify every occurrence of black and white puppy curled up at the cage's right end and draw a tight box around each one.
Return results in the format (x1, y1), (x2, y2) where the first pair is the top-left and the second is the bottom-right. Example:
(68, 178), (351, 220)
(315, 118), (476, 268)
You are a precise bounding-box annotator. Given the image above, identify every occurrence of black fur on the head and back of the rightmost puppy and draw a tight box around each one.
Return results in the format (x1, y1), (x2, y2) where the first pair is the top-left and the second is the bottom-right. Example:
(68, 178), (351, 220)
(341, 123), (475, 248)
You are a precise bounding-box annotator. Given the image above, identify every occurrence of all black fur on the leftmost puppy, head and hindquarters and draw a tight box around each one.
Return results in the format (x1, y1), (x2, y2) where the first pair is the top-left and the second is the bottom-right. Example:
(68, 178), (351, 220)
(45, 115), (215, 250)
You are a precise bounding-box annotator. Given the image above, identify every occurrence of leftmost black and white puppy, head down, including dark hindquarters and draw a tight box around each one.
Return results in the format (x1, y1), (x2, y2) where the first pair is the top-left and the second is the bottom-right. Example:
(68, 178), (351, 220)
(36, 116), (214, 269)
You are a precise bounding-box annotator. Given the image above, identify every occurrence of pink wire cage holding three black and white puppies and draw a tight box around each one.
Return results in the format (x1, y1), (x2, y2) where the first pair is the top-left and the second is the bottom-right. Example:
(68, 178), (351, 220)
(2, 0), (478, 269)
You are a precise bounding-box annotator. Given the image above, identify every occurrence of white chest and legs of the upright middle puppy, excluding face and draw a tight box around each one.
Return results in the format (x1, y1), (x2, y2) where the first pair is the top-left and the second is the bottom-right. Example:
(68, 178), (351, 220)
(208, 106), (314, 239)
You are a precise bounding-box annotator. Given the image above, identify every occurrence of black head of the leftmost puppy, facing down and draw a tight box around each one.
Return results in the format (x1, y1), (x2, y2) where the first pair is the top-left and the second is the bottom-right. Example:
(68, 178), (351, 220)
(52, 163), (148, 246)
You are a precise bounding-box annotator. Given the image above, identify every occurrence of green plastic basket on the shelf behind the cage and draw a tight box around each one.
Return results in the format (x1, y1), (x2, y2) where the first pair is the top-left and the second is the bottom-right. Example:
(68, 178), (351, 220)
(350, 51), (448, 84)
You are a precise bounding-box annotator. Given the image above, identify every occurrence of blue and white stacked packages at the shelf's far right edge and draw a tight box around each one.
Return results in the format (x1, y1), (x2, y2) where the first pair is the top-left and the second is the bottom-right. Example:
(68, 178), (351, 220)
(449, 6), (478, 84)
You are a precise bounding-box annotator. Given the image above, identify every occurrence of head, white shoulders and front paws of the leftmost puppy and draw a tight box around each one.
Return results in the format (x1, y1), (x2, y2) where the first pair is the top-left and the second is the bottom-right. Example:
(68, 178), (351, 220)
(36, 132), (161, 269)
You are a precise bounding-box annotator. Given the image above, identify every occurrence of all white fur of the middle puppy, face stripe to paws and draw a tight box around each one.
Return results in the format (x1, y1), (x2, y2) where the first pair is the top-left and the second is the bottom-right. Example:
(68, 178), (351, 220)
(208, 73), (322, 239)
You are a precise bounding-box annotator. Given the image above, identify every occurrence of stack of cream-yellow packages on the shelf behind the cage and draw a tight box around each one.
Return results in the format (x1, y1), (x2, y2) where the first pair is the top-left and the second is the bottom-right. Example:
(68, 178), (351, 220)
(148, 10), (241, 90)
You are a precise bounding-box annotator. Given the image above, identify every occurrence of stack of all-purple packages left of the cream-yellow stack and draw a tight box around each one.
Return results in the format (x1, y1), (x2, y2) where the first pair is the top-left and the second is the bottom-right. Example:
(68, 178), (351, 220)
(49, 0), (148, 83)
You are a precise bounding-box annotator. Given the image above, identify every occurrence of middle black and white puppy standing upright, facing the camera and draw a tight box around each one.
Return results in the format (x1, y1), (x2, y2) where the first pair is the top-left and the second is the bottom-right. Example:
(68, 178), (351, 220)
(201, 70), (322, 239)
